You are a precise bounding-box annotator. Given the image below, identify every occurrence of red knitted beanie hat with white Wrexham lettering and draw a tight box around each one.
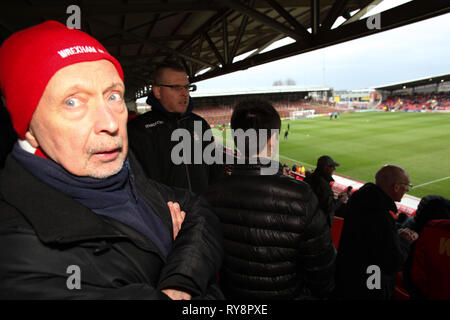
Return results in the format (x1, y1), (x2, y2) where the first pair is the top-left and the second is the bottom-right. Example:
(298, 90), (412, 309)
(0, 21), (123, 139)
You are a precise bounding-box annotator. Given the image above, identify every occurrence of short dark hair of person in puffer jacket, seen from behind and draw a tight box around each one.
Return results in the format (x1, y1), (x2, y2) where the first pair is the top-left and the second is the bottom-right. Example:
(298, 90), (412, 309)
(231, 99), (281, 158)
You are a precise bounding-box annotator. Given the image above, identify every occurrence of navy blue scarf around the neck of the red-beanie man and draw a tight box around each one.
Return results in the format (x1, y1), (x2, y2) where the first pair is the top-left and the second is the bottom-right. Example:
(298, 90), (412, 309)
(12, 143), (172, 256)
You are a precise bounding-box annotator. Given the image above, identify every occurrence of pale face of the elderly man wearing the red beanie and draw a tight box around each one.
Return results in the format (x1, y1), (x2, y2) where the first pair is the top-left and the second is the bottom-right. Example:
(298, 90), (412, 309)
(25, 60), (128, 178)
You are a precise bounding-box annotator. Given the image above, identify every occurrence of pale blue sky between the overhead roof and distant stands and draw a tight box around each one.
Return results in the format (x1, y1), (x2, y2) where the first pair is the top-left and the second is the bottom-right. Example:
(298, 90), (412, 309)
(197, 5), (450, 92)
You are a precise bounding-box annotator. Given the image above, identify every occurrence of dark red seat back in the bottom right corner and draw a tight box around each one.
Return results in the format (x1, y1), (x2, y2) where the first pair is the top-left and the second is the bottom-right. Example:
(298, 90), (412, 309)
(411, 220), (450, 300)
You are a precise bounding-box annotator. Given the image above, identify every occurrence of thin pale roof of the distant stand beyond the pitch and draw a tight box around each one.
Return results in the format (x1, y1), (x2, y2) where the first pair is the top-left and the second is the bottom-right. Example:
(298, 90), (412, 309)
(190, 86), (333, 98)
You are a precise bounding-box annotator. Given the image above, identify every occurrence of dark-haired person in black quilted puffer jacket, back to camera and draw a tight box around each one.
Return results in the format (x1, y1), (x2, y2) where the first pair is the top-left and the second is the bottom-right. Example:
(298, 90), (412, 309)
(205, 100), (336, 300)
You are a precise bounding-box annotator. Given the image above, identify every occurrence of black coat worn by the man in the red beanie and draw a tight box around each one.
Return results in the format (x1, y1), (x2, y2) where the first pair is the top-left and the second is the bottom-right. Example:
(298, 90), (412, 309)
(0, 155), (223, 299)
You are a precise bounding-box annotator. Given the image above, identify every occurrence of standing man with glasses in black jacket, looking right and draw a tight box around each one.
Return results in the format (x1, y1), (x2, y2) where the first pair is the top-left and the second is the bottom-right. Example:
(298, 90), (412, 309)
(128, 62), (224, 194)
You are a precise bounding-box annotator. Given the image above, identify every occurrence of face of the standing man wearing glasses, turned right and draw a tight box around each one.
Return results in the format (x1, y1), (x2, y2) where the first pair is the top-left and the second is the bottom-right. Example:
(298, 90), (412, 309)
(153, 69), (189, 114)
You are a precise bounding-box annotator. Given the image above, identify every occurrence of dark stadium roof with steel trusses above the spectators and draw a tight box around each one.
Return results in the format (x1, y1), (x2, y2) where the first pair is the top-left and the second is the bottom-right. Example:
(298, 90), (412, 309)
(0, 0), (450, 99)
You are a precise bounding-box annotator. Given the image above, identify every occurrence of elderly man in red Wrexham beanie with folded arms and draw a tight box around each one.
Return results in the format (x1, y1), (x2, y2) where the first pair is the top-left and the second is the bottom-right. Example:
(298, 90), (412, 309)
(0, 21), (222, 299)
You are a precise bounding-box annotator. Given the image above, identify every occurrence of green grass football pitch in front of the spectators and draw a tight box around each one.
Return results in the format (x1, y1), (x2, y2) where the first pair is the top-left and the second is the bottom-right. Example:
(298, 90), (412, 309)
(213, 112), (450, 198)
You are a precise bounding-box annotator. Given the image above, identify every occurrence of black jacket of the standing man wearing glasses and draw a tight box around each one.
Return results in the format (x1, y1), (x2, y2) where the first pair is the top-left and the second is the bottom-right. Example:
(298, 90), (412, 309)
(128, 95), (224, 194)
